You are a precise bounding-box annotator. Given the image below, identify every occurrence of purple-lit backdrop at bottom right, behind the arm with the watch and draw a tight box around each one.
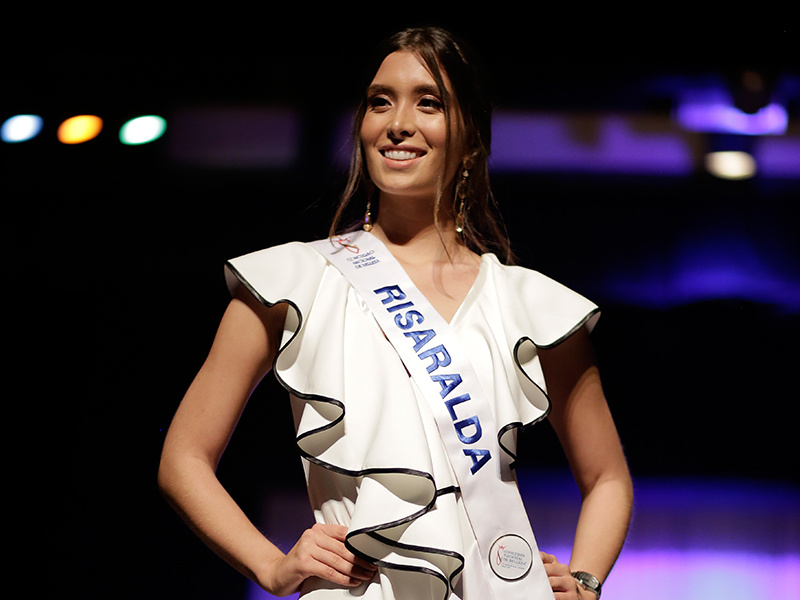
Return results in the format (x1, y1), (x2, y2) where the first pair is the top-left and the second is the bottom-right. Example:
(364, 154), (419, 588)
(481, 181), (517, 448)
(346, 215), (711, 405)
(247, 471), (800, 600)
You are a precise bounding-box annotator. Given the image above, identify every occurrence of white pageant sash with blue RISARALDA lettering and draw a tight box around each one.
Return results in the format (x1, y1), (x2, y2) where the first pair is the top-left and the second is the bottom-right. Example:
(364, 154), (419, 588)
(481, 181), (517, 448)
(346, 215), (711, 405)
(309, 231), (553, 600)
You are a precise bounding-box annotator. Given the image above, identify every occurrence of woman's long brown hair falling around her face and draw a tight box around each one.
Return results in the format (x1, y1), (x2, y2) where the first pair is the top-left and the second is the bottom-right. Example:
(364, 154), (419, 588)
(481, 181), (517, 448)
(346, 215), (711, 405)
(330, 27), (514, 264)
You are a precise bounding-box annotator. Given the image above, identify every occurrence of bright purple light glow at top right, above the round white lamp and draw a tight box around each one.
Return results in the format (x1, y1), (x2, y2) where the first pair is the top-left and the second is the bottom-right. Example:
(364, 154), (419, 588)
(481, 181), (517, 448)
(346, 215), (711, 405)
(675, 90), (789, 135)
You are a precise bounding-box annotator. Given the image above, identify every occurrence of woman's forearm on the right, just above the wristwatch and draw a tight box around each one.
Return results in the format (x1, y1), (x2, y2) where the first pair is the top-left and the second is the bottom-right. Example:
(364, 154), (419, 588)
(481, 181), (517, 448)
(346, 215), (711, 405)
(569, 473), (633, 581)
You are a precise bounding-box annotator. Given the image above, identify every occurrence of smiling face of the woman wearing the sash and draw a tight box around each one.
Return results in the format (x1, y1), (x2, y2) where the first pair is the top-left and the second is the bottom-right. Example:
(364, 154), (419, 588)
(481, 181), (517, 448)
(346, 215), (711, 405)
(361, 51), (462, 200)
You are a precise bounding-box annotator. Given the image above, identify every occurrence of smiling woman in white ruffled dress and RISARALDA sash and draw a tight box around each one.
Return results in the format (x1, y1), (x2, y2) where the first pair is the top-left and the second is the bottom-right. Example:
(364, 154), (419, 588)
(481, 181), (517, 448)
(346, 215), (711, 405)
(159, 28), (632, 600)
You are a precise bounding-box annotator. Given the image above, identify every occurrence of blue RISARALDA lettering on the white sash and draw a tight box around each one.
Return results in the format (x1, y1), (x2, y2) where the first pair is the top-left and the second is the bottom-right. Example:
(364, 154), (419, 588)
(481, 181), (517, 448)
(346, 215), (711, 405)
(373, 285), (492, 475)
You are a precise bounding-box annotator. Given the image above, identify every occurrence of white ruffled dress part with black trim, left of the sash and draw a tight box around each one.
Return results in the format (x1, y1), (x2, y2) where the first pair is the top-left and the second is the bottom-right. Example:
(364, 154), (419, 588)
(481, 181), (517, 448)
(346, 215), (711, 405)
(226, 243), (469, 599)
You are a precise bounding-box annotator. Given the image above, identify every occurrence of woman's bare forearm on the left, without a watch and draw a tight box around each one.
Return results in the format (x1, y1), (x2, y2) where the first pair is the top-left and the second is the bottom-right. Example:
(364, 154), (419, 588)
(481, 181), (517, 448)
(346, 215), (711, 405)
(158, 452), (284, 587)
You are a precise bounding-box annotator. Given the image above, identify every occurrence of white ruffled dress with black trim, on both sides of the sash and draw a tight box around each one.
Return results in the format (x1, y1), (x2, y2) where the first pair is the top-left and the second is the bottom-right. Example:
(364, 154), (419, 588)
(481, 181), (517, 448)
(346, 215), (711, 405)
(226, 242), (599, 600)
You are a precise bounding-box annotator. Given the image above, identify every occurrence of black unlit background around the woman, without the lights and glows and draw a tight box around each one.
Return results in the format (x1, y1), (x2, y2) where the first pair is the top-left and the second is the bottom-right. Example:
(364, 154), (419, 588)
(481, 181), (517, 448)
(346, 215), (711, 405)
(6, 14), (800, 598)
